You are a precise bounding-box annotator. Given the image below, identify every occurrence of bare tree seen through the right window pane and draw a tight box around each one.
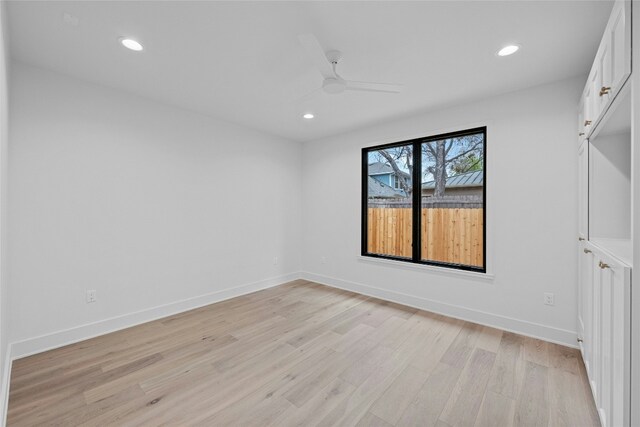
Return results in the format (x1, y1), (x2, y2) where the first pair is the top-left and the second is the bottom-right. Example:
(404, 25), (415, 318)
(422, 134), (484, 197)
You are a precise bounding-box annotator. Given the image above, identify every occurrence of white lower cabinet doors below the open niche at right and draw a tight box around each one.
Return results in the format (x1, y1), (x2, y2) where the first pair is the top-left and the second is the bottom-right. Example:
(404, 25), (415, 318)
(578, 241), (631, 427)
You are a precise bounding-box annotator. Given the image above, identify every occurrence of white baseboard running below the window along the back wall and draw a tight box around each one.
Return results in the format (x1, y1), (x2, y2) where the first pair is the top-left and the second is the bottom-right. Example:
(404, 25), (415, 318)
(302, 272), (578, 348)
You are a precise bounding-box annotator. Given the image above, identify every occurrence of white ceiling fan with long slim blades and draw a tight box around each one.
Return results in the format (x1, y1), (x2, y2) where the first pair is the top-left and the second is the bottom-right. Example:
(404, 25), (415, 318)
(298, 34), (402, 94)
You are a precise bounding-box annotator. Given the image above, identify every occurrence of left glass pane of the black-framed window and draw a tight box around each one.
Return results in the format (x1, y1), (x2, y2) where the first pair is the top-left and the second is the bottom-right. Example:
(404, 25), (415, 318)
(367, 145), (413, 258)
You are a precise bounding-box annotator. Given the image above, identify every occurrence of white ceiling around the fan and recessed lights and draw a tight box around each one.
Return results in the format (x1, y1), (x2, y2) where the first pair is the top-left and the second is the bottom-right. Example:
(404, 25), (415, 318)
(9, 1), (612, 141)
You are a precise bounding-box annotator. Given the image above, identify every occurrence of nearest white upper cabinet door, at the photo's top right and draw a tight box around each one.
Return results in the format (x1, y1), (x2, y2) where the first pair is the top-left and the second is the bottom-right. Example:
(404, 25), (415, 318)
(604, 0), (631, 97)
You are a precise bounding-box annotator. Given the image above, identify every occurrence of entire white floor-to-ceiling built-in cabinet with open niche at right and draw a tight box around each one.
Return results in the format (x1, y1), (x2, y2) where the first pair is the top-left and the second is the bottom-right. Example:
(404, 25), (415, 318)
(577, 0), (639, 427)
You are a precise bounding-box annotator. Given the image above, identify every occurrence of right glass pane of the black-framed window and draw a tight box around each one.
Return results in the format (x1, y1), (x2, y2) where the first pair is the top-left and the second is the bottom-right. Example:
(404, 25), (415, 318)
(420, 133), (485, 268)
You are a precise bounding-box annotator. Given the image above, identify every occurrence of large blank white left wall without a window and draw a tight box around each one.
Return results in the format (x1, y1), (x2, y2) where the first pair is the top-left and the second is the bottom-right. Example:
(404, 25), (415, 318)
(9, 64), (301, 356)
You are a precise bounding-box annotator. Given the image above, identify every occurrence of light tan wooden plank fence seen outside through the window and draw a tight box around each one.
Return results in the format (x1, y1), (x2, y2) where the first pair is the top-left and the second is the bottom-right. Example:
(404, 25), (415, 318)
(367, 207), (484, 267)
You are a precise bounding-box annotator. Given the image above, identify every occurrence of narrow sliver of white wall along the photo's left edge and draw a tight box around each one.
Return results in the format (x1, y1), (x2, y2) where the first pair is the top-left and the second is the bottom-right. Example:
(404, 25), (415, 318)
(0, 0), (9, 422)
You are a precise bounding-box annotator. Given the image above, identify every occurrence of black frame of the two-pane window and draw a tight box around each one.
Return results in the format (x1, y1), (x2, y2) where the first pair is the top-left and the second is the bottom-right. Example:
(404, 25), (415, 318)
(360, 126), (487, 273)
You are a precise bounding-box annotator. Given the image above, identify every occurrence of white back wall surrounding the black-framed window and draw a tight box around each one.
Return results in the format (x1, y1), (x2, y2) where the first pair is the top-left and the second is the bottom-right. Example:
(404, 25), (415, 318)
(302, 78), (584, 346)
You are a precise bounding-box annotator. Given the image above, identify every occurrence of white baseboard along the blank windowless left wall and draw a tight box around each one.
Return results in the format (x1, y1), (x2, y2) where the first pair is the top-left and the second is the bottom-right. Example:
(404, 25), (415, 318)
(10, 272), (301, 360)
